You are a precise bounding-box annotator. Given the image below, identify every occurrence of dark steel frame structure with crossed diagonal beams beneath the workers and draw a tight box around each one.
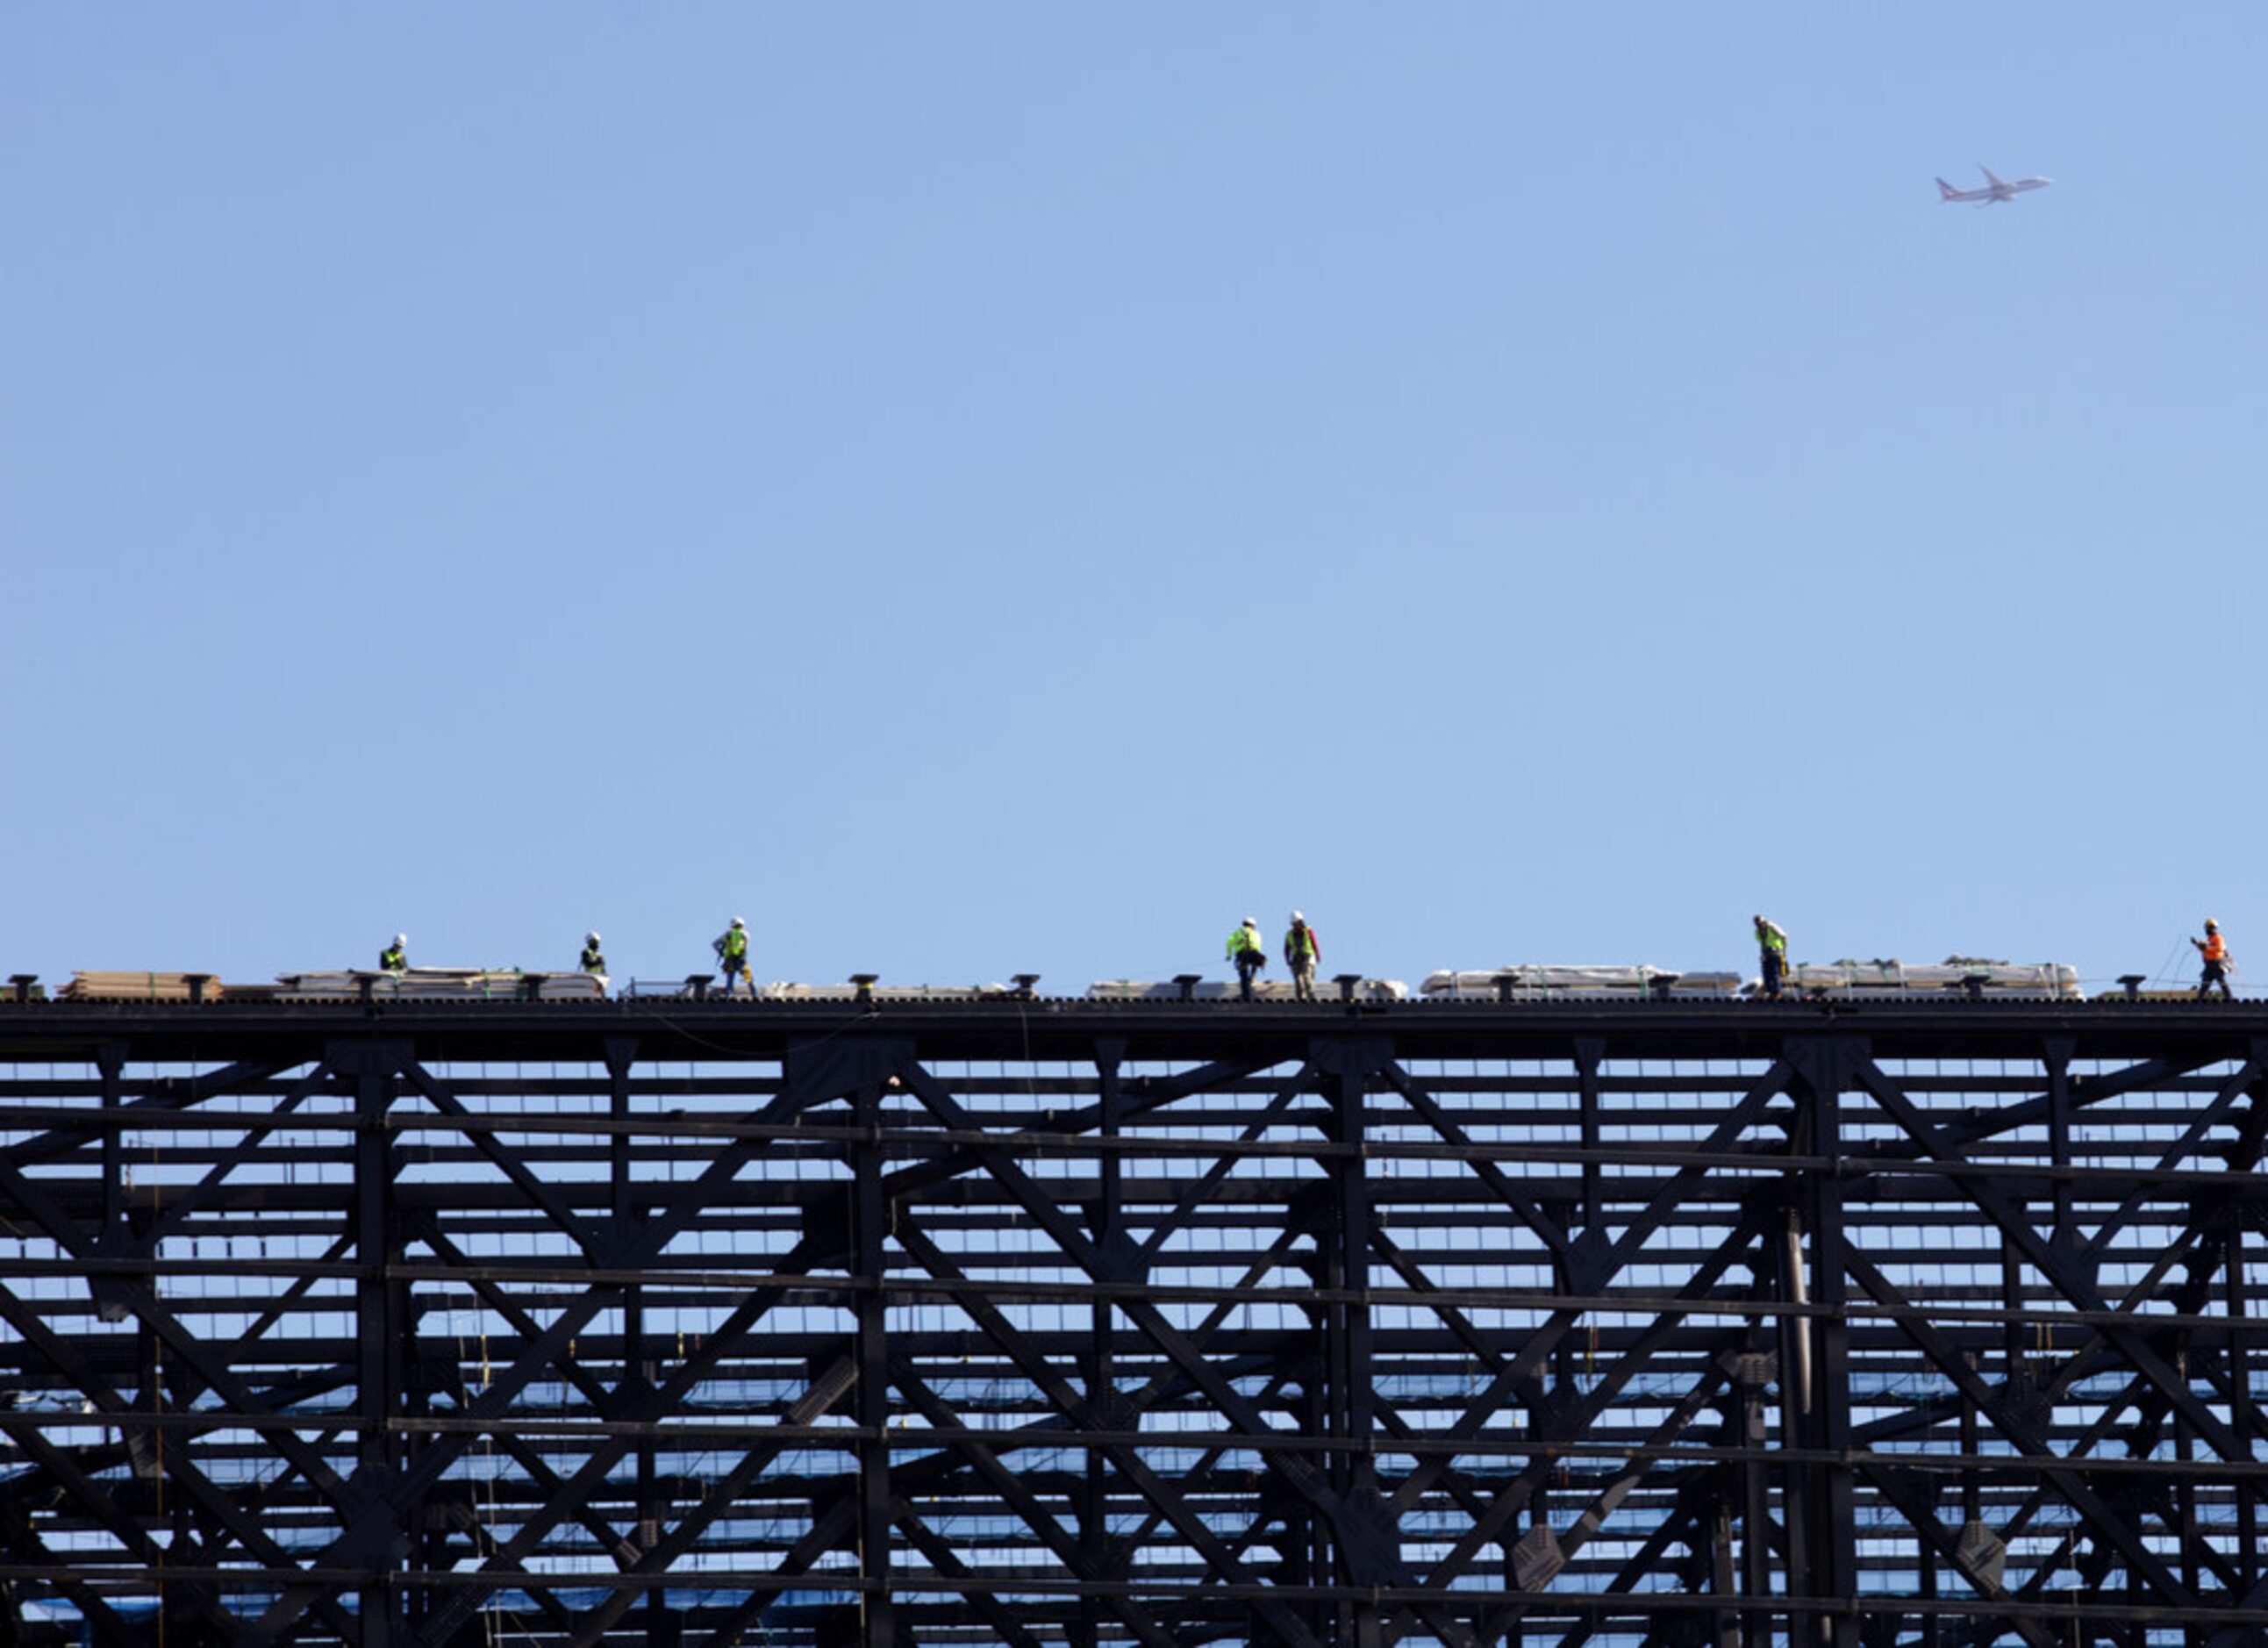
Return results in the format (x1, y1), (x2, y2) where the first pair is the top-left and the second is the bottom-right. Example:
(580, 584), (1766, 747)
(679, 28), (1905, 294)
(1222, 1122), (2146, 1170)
(0, 999), (2268, 1648)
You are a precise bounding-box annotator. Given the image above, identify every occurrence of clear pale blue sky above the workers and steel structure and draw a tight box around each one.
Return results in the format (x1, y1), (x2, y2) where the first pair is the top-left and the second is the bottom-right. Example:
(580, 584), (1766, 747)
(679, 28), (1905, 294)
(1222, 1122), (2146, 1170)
(0, 0), (2268, 992)
